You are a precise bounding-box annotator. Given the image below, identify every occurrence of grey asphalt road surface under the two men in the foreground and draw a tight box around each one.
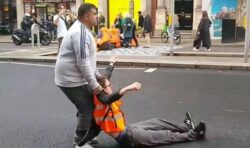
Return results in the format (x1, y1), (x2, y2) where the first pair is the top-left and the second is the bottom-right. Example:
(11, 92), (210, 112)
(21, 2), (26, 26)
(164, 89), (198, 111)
(0, 63), (250, 148)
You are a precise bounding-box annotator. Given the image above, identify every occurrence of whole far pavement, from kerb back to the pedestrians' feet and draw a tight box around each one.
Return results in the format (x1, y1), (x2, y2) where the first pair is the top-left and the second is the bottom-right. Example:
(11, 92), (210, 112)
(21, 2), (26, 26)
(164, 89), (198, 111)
(0, 36), (250, 71)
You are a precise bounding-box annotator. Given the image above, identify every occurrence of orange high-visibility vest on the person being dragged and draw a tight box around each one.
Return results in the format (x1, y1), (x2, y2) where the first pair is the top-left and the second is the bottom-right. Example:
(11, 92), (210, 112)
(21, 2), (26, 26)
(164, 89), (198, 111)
(94, 95), (126, 133)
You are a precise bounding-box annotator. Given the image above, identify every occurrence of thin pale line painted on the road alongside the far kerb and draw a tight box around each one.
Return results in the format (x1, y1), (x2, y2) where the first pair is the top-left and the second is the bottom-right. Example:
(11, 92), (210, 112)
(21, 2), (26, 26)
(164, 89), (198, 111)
(0, 62), (145, 70)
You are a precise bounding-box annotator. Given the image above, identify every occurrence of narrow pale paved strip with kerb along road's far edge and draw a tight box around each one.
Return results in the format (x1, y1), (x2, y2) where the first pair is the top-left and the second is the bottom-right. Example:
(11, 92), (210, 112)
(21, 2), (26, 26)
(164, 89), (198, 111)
(0, 49), (250, 71)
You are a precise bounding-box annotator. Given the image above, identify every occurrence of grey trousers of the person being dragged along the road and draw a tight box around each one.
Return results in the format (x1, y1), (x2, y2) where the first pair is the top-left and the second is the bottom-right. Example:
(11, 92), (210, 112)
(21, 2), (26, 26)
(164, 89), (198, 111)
(118, 118), (189, 147)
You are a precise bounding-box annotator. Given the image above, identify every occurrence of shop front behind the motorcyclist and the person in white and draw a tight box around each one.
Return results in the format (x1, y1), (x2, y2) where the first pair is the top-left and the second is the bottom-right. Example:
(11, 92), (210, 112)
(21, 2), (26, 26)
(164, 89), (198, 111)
(23, 0), (76, 23)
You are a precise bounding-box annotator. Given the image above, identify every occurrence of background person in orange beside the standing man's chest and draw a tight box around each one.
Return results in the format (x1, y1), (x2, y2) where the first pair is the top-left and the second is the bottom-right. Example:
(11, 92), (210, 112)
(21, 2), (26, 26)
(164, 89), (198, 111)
(97, 24), (111, 50)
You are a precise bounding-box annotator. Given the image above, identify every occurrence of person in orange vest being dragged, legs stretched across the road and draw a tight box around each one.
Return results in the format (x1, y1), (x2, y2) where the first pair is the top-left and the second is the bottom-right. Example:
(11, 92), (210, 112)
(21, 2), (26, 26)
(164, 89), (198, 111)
(94, 56), (206, 147)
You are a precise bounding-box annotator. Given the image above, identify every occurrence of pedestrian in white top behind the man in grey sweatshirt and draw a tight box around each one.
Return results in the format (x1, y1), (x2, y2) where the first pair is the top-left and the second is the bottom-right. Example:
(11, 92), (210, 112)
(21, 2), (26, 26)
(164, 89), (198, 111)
(54, 5), (68, 52)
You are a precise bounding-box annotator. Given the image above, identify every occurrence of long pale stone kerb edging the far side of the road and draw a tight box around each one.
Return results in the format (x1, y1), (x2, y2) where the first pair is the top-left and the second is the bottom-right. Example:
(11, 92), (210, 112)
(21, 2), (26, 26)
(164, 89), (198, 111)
(0, 57), (250, 71)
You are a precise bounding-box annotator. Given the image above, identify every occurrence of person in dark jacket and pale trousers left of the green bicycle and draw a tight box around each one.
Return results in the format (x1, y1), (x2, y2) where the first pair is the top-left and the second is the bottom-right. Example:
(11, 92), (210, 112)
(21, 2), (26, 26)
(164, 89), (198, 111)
(143, 11), (152, 48)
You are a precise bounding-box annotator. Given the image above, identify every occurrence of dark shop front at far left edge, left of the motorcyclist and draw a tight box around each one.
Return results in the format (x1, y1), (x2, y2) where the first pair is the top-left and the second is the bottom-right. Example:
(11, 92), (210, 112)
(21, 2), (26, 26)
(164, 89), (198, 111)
(0, 0), (16, 34)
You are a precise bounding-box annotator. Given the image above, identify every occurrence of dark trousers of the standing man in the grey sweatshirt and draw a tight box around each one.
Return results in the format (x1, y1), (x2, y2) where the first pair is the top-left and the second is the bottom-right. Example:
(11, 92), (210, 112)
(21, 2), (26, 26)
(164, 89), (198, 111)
(59, 85), (100, 141)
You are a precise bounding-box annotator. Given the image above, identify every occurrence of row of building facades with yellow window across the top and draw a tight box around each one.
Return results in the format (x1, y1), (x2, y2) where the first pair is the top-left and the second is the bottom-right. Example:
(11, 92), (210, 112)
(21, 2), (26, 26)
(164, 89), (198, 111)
(5, 0), (246, 36)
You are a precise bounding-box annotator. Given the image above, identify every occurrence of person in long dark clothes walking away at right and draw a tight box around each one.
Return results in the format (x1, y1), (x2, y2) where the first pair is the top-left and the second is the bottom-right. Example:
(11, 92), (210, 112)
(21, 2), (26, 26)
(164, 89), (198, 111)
(193, 11), (212, 51)
